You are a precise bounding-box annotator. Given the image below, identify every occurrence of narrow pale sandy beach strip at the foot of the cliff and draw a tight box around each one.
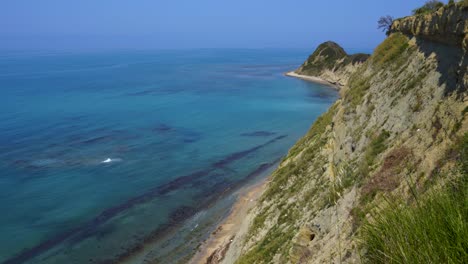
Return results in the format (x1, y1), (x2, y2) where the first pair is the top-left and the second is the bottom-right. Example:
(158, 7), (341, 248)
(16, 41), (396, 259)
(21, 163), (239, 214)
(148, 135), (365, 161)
(189, 176), (270, 264)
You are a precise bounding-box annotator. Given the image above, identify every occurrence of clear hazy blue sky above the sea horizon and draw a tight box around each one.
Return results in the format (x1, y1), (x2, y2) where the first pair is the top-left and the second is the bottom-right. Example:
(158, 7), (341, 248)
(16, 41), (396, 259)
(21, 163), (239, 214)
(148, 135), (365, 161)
(0, 0), (432, 50)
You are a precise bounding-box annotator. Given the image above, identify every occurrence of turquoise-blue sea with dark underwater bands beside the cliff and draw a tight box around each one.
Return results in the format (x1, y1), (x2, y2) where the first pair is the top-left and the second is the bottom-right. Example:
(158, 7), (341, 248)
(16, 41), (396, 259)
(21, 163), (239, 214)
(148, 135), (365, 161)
(0, 50), (338, 263)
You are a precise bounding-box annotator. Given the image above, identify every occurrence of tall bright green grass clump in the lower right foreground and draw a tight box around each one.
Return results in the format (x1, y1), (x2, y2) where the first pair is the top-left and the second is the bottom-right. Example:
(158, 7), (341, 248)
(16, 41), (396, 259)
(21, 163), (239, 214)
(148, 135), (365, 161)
(361, 134), (468, 263)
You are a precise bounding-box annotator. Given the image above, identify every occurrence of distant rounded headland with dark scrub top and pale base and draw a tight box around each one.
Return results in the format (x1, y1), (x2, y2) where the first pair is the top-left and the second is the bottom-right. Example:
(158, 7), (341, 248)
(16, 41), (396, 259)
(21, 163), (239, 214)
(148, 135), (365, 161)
(295, 41), (369, 86)
